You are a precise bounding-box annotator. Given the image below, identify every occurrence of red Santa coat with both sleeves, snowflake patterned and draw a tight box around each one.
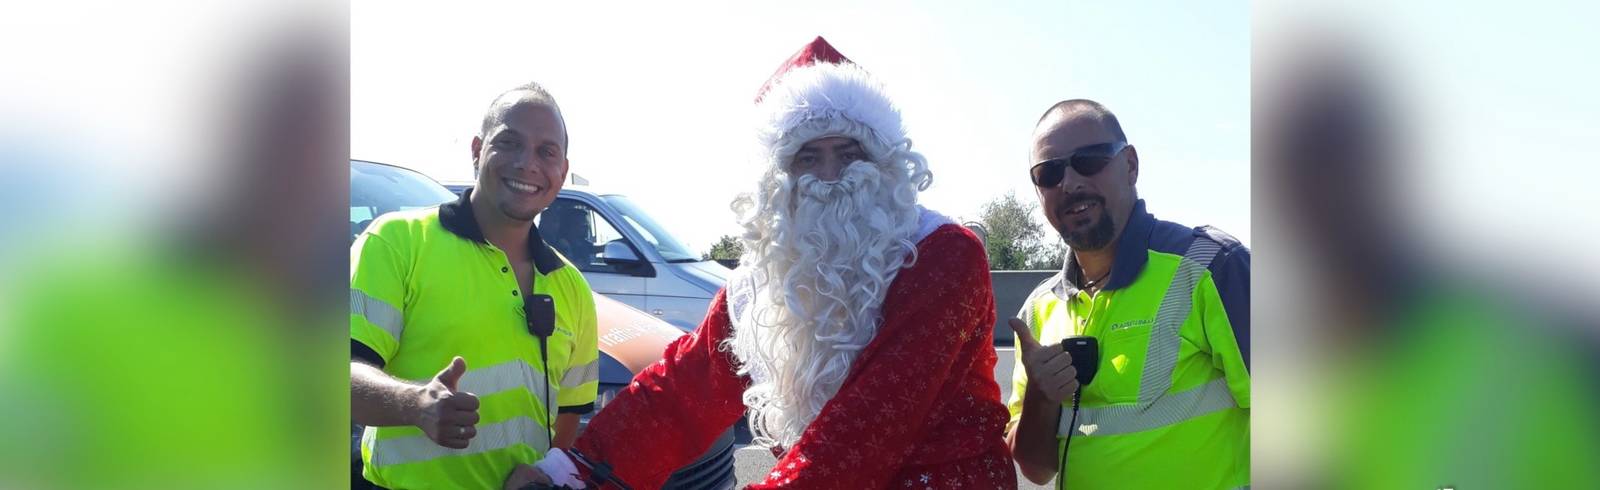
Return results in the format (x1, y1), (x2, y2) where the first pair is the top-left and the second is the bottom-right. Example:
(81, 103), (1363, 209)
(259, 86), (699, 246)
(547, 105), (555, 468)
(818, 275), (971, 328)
(576, 224), (1016, 488)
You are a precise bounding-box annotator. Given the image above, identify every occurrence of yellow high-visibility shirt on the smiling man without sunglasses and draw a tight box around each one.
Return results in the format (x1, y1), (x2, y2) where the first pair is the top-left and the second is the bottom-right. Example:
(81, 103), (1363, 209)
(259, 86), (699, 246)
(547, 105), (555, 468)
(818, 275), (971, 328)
(350, 189), (600, 488)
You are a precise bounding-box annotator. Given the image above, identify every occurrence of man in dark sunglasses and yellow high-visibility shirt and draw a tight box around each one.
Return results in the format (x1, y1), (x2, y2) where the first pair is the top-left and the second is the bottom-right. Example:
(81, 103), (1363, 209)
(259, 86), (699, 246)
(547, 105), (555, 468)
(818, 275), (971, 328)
(1008, 99), (1250, 488)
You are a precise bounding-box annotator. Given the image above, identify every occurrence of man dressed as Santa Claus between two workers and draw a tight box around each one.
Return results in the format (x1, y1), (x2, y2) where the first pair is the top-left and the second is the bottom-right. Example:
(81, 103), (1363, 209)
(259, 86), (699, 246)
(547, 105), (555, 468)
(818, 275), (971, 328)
(507, 37), (1016, 488)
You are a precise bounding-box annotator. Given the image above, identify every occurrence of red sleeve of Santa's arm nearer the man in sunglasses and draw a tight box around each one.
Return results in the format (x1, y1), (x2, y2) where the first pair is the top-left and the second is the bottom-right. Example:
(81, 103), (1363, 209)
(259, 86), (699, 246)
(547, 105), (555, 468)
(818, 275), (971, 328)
(750, 231), (994, 488)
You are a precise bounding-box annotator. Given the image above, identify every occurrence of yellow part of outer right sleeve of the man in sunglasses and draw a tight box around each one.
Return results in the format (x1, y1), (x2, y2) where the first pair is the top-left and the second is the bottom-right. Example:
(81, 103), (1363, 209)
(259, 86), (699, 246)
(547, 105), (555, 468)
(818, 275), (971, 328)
(1195, 247), (1250, 408)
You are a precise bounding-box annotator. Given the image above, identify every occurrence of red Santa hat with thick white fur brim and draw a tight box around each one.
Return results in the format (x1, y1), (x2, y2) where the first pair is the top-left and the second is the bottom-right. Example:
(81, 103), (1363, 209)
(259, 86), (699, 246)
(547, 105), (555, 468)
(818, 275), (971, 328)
(755, 37), (909, 168)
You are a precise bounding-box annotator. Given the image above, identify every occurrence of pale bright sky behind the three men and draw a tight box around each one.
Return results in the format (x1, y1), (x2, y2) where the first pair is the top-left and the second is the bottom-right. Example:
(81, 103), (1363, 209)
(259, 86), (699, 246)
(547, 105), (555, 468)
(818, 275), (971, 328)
(350, 0), (1251, 251)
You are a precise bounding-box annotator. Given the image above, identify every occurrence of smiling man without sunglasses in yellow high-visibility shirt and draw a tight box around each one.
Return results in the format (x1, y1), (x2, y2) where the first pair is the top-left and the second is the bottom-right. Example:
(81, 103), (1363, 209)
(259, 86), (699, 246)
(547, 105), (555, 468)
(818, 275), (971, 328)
(350, 83), (598, 488)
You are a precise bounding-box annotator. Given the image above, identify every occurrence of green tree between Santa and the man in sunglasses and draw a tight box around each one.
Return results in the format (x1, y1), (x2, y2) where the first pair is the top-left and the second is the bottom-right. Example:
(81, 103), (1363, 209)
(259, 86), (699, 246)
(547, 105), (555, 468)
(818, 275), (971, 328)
(978, 192), (1066, 271)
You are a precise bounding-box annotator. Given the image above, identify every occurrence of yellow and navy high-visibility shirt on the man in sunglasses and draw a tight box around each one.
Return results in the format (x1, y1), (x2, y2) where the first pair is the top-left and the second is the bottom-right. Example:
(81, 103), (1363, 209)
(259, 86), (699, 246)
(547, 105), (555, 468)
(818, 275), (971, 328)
(1010, 200), (1250, 488)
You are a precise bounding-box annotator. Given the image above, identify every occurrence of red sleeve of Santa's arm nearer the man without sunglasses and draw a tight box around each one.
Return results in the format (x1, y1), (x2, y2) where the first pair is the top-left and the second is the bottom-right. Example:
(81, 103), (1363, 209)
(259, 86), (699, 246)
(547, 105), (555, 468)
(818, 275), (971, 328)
(574, 291), (747, 488)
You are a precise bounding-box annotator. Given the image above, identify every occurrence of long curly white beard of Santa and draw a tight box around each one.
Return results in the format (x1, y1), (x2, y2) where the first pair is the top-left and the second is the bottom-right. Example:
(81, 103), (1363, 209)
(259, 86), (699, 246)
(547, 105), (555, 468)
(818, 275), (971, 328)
(728, 162), (918, 447)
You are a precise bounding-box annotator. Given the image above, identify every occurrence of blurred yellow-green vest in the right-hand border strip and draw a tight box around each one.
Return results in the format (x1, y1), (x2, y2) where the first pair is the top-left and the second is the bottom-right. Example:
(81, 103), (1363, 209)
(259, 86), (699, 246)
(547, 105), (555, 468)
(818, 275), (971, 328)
(1324, 286), (1600, 488)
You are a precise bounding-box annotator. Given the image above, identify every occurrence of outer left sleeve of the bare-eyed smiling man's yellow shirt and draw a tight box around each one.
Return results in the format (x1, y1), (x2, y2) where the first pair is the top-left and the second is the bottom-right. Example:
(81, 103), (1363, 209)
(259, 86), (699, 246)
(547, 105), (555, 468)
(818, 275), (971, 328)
(350, 219), (408, 363)
